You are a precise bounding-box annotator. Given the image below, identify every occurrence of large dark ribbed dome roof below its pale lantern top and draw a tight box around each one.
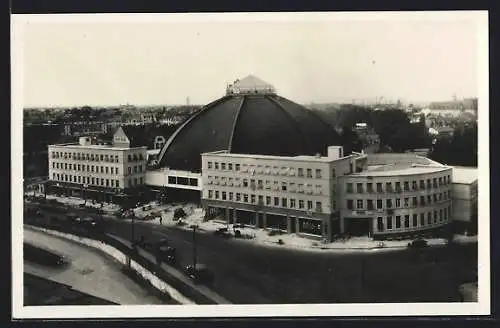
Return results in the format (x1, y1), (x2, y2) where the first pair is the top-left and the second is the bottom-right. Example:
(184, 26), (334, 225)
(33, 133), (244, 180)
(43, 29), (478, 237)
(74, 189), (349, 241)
(159, 94), (340, 171)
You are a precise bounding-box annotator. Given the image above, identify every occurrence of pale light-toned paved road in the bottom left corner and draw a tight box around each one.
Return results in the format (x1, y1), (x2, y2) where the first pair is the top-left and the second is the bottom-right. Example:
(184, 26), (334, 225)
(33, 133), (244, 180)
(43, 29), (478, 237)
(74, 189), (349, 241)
(24, 228), (163, 305)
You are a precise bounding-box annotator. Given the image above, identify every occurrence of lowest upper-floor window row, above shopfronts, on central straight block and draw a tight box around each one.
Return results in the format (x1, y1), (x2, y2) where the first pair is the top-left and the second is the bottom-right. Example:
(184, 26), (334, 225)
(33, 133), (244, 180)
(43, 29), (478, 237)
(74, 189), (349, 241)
(208, 190), (323, 213)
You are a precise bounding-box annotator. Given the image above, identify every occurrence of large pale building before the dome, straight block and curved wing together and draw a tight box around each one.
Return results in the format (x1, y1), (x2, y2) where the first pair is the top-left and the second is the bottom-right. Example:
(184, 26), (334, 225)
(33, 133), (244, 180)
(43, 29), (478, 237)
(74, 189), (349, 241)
(202, 146), (452, 240)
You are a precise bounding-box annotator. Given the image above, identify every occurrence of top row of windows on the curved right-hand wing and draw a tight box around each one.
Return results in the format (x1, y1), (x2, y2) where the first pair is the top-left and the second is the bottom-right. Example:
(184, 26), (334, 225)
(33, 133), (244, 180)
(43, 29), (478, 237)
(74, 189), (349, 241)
(346, 175), (451, 194)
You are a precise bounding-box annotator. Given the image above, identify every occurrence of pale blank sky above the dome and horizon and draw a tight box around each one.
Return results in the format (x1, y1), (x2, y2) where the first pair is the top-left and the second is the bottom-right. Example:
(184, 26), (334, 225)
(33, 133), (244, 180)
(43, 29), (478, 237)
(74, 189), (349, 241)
(14, 14), (479, 107)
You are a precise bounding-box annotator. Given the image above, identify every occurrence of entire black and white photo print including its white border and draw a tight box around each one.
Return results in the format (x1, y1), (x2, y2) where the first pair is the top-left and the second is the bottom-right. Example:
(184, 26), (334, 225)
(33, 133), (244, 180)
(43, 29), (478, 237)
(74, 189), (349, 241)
(11, 11), (490, 319)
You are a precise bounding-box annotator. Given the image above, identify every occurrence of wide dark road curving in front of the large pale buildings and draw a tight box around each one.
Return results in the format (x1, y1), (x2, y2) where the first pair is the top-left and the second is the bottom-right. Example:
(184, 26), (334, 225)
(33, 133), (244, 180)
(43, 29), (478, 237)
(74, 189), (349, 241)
(26, 204), (477, 304)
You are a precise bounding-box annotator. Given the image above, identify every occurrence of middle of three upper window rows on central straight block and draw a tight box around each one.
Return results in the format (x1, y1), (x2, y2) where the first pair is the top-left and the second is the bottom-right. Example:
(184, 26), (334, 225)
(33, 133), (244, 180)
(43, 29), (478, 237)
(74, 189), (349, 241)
(207, 176), (323, 195)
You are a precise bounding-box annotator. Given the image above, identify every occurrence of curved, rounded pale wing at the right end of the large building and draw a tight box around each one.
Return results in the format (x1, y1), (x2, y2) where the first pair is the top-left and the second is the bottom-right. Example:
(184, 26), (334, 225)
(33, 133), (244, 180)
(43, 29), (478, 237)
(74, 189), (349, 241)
(339, 154), (452, 238)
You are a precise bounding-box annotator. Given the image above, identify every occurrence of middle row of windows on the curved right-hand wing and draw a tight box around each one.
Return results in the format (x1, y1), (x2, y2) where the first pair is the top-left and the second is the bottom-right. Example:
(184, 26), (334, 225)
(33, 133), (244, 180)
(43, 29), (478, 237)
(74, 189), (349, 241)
(346, 190), (451, 210)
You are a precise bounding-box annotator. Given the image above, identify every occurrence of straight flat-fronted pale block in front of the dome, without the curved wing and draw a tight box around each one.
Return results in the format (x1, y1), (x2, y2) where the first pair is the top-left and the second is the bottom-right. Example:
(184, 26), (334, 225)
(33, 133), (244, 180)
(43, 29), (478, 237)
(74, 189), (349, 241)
(202, 146), (364, 239)
